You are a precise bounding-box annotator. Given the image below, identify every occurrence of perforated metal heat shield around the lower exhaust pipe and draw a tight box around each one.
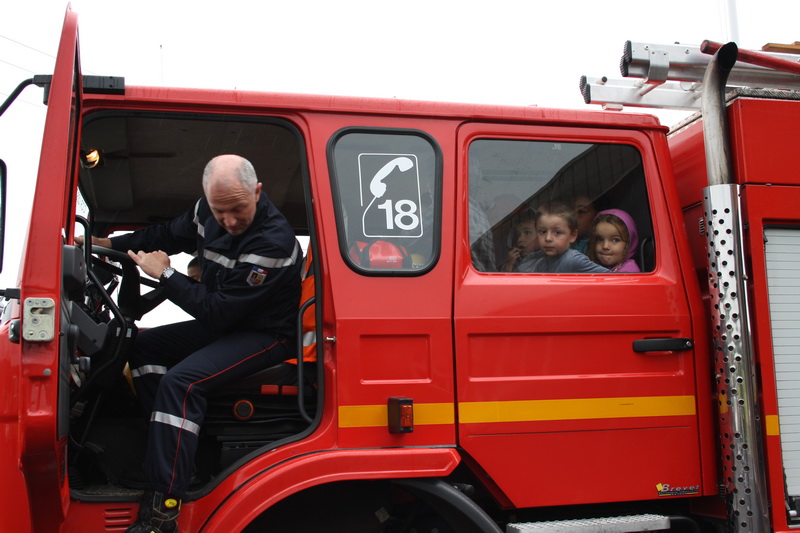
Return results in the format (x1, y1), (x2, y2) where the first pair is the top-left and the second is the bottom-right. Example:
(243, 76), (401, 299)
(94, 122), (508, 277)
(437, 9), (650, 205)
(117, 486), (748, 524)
(704, 185), (769, 533)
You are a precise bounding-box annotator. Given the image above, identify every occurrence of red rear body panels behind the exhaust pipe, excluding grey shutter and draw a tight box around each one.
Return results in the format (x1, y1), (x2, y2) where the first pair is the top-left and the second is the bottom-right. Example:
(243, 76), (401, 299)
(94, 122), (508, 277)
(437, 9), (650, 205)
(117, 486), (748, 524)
(669, 94), (800, 531)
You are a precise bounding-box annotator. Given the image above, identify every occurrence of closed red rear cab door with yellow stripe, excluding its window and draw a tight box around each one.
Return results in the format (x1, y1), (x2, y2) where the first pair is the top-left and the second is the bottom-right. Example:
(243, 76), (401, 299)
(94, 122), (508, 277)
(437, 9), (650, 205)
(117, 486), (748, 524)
(455, 120), (714, 507)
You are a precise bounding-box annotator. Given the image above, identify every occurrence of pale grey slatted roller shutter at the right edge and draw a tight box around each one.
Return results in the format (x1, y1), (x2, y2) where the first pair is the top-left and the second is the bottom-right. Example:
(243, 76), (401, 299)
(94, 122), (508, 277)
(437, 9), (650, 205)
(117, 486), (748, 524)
(764, 228), (800, 497)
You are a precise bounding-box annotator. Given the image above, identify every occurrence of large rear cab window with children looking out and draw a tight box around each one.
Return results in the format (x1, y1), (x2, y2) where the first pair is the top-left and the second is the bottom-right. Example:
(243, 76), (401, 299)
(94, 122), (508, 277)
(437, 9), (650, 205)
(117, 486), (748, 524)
(469, 139), (654, 273)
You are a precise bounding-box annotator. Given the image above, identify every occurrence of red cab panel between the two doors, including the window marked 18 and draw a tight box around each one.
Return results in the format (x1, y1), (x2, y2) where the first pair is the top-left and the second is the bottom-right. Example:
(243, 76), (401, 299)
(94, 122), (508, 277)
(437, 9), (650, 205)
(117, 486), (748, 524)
(318, 114), (456, 448)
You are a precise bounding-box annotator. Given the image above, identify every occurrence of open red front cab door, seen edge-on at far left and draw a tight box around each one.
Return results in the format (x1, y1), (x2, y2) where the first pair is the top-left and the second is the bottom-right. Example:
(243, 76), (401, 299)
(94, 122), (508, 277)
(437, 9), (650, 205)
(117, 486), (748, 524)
(7, 7), (82, 531)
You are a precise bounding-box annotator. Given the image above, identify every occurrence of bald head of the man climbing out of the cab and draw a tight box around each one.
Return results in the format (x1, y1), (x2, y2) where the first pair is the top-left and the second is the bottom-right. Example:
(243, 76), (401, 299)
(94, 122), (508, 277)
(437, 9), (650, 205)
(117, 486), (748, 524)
(203, 154), (261, 235)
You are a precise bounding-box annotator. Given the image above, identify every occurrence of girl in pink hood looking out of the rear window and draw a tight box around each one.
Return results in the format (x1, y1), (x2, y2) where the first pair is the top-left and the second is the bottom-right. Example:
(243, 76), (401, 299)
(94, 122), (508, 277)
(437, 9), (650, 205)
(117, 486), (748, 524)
(588, 209), (640, 272)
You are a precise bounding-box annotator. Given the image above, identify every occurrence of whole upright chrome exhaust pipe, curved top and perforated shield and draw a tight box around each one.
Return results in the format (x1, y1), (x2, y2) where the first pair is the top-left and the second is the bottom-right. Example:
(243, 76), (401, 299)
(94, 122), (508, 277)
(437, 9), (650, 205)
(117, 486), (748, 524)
(702, 43), (778, 533)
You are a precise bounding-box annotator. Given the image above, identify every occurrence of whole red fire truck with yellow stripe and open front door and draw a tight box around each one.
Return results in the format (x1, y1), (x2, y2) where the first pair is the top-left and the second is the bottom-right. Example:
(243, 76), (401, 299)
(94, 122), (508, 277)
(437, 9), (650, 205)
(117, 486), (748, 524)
(0, 5), (800, 533)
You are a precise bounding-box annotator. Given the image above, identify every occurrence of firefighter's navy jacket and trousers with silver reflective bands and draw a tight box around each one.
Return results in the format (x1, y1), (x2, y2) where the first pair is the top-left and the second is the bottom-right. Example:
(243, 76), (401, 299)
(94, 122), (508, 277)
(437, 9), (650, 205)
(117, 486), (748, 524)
(112, 193), (302, 498)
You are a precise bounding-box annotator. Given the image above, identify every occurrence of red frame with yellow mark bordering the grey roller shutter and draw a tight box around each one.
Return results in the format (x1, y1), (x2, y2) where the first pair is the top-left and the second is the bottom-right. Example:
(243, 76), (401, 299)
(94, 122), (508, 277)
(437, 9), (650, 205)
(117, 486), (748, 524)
(743, 186), (800, 531)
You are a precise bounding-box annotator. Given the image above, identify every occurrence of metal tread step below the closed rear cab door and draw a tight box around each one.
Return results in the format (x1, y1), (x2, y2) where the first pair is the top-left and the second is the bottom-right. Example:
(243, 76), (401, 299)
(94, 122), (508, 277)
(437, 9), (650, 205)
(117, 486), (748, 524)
(506, 514), (669, 533)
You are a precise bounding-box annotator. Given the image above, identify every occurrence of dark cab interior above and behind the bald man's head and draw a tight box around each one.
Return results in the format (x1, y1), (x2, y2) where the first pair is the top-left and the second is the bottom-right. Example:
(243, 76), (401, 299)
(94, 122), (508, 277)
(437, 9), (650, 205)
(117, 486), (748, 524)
(79, 114), (308, 235)
